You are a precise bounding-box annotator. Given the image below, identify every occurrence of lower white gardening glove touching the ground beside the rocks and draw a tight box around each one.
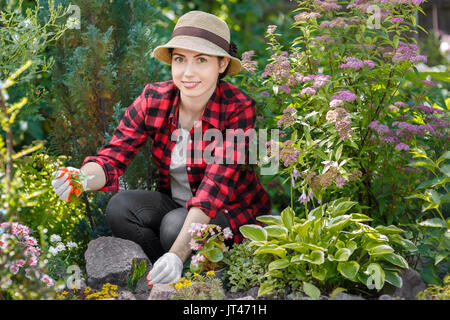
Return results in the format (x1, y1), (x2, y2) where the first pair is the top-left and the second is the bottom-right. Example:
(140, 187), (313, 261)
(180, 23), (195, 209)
(147, 252), (183, 285)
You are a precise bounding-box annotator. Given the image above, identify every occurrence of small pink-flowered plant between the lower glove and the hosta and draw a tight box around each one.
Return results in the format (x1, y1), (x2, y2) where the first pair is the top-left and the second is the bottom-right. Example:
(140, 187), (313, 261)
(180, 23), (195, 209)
(189, 223), (233, 273)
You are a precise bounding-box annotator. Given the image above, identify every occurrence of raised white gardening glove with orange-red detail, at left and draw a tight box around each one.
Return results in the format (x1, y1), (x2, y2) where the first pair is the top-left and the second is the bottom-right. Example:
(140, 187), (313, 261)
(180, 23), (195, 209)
(52, 167), (89, 202)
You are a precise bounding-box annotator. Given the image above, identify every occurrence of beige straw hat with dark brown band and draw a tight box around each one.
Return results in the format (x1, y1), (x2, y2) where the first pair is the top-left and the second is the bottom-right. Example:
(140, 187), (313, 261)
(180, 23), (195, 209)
(153, 10), (241, 75)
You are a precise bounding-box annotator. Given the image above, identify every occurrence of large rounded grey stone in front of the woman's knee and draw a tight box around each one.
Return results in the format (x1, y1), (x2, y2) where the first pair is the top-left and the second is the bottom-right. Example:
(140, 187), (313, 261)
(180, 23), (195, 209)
(84, 237), (151, 291)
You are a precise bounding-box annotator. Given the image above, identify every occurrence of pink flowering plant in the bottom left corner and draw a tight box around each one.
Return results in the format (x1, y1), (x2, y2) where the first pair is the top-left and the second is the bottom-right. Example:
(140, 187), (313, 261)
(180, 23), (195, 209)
(0, 222), (56, 299)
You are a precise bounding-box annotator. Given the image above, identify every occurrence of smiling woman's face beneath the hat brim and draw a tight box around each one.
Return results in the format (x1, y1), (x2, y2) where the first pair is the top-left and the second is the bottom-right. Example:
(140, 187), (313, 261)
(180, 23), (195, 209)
(172, 48), (230, 99)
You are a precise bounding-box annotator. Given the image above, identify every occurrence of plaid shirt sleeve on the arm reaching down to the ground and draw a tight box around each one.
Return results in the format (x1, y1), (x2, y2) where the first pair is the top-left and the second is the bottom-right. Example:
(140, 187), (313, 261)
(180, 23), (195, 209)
(186, 100), (256, 219)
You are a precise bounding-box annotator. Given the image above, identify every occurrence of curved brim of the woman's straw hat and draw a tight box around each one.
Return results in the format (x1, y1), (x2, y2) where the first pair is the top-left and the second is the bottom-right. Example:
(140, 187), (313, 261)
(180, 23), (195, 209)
(152, 35), (242, 75)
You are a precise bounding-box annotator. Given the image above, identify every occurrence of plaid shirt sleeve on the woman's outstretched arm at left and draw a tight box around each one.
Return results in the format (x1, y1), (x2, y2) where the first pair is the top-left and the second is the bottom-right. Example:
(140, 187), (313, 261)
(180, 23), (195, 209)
(83, 85), (154, 191)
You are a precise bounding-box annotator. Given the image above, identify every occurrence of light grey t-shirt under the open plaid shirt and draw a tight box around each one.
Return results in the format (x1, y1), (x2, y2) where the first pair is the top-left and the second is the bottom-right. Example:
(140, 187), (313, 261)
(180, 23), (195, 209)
(169, 121), (193, 207)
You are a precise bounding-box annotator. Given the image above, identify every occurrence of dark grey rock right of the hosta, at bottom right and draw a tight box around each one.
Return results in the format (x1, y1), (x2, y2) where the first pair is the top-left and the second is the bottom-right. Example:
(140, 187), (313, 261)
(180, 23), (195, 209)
(381, 269), (427, 300)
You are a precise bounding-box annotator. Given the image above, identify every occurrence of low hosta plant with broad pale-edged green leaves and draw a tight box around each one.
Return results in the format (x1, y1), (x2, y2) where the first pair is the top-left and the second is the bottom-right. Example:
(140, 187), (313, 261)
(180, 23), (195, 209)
(240, 198), (416, 298)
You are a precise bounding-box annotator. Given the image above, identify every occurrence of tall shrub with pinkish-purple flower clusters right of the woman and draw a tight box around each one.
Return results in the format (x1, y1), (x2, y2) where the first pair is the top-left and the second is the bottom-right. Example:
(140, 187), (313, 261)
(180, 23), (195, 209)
(239, 0), (450, 223)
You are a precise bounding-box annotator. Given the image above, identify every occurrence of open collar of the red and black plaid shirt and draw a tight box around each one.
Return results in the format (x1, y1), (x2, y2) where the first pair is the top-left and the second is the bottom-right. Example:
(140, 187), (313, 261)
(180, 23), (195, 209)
(169, 81), (222, 129)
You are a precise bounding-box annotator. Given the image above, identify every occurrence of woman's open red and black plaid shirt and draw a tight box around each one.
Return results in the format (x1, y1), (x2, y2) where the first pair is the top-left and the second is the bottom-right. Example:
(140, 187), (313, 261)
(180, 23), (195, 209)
(83, 80), (271, 243)
